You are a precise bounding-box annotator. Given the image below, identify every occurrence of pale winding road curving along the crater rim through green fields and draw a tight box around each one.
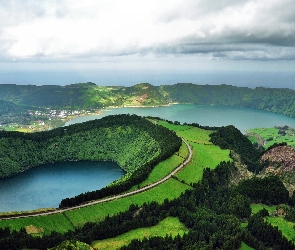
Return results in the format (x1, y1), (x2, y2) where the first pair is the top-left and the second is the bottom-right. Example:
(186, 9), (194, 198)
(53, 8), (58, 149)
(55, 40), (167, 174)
(0, 138), (193, 220)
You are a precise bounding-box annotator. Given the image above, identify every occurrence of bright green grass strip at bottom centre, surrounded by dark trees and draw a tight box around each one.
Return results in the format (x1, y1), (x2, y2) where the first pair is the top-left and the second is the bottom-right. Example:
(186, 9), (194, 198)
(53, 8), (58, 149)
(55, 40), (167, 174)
(92, 217), (188, 250)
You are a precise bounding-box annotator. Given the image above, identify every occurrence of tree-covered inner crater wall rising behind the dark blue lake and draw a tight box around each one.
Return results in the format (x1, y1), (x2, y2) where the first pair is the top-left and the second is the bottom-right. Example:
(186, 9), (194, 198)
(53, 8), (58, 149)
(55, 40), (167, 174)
(0, 115), (181, 177)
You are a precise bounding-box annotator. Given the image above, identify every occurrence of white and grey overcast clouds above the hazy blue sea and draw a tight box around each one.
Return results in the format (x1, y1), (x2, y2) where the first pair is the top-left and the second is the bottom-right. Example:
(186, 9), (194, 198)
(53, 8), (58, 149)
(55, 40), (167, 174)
(0, 0), (295, 86)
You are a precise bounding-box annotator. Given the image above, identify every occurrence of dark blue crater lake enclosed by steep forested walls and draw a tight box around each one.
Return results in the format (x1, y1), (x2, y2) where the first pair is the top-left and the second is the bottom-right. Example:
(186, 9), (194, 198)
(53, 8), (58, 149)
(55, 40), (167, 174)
(0, 161), (124, 212)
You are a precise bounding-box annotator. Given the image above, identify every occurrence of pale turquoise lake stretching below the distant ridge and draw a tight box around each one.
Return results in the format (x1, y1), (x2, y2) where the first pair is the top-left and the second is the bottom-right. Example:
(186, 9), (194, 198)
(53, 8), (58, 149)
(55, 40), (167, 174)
(66, 104), (295, 132)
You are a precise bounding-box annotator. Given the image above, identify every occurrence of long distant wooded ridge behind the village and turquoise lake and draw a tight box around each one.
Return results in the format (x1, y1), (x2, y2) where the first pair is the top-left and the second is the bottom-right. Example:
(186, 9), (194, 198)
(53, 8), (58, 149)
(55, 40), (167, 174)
(0, 82), (295, 124)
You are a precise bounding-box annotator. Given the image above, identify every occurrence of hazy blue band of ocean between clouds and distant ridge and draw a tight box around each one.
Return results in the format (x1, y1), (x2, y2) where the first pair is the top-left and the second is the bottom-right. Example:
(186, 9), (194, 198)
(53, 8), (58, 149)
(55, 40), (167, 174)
(0, 69), (295, 89)
